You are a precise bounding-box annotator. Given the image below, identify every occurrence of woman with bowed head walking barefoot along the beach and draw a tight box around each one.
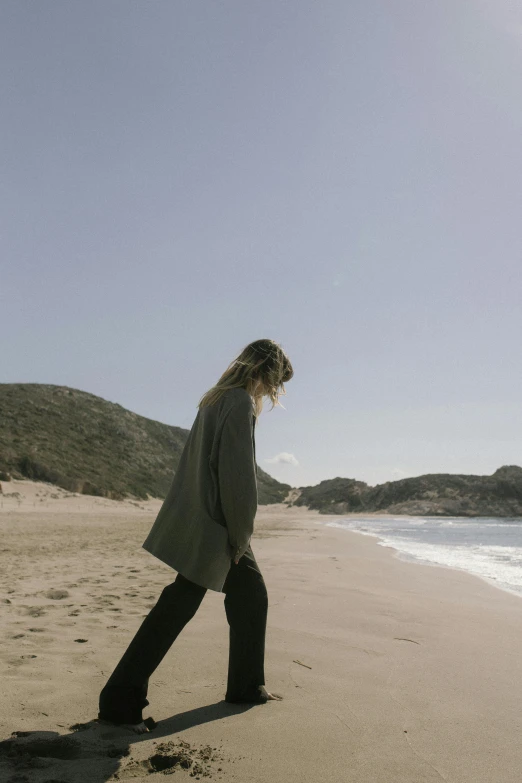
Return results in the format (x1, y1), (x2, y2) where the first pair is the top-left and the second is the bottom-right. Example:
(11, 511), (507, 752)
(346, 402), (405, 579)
(98, 340), (294, 734)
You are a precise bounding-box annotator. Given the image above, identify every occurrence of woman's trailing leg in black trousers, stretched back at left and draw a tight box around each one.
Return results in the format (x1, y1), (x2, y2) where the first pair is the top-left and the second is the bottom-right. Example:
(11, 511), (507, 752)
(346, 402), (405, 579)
(98, 574), (207, 724)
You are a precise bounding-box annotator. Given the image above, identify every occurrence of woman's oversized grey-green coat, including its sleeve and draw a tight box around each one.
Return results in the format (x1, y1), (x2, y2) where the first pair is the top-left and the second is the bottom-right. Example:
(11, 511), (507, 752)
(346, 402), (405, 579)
(142, 388), (257, 592)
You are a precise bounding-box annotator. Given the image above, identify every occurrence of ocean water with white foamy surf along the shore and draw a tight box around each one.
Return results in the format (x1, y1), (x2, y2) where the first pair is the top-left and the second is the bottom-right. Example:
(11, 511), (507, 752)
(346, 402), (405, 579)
(326, 516), (522, 597)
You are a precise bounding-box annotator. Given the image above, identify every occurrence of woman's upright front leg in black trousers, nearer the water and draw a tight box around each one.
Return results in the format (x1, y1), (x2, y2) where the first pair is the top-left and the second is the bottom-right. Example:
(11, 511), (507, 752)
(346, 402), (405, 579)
(223, 546), (268, 702)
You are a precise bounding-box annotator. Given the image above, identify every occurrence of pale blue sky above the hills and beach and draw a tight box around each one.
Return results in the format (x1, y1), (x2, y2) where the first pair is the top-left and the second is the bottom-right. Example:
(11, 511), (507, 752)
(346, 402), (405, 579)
(0, 0), (522, 486)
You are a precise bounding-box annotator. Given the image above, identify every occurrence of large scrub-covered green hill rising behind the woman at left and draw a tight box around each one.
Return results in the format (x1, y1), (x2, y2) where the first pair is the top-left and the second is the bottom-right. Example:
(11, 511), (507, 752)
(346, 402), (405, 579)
(0, 383), (290, 504)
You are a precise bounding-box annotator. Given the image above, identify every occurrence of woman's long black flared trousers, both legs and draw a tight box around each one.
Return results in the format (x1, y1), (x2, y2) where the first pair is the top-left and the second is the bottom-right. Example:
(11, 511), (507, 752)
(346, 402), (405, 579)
(98, 546), (268, 723)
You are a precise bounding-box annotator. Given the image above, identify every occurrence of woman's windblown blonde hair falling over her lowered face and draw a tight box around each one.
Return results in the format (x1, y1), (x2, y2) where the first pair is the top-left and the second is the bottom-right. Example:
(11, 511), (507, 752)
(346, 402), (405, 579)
(198, 339), (294, 418)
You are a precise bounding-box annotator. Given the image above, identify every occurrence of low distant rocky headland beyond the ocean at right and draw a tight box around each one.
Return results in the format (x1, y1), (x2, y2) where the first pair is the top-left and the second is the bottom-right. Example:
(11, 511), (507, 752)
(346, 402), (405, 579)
(289, 465), (522, 517)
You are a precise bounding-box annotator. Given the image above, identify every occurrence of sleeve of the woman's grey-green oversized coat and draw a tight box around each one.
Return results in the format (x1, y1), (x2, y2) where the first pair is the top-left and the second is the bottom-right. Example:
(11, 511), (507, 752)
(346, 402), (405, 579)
(218, 400), (257, 557)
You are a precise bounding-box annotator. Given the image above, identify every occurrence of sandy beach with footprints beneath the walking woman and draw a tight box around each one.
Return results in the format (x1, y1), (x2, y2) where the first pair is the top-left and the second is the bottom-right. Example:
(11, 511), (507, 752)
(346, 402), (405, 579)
(0, 481), (522, 783)
